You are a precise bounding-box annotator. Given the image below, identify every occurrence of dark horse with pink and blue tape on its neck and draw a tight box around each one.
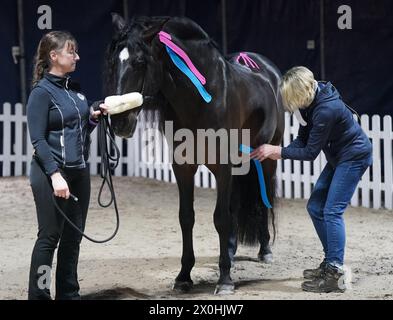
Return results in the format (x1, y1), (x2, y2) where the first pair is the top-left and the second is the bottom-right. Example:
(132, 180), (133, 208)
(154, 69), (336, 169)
(106, 14), (284, 293)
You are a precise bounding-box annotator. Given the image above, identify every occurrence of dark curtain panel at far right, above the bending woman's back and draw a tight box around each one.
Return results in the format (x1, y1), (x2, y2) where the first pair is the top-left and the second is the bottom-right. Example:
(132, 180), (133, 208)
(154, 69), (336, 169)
(326, 0), (393, 115)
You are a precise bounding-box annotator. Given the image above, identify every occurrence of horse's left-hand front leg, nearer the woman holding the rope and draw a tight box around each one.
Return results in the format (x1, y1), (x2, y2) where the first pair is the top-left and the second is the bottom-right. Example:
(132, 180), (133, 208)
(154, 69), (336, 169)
(172, 164), (197, 292)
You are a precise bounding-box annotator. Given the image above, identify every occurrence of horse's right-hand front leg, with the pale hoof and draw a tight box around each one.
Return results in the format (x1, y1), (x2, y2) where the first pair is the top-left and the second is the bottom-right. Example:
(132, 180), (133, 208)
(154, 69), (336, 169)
(214, 165), (235, 294)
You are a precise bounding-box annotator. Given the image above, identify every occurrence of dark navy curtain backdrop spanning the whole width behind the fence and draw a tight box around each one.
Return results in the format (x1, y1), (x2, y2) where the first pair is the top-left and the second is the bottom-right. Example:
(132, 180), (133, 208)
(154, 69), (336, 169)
(0, 0), (393, 115)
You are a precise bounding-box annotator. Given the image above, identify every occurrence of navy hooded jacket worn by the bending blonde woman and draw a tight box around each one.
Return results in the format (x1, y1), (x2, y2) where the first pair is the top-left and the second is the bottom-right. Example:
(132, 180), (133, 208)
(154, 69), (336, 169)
(281, 82), (372, 167)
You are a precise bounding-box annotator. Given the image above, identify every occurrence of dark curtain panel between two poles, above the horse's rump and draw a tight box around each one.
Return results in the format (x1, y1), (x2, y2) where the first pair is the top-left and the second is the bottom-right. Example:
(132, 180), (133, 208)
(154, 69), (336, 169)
(227, 0), (320, 76)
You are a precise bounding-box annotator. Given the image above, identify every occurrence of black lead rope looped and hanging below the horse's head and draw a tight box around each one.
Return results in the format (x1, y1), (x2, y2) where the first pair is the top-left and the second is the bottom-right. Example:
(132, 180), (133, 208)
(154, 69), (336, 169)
(52, 115), (120, 243)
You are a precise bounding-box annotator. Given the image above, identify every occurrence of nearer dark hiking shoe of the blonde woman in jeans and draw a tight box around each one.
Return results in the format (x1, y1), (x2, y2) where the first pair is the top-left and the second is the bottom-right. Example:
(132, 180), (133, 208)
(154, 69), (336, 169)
(302, 265), (346, 293)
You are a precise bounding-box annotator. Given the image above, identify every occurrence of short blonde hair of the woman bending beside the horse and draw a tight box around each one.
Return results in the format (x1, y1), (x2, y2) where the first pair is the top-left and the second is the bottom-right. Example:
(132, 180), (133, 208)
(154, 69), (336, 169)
(280, 67), (317, 112)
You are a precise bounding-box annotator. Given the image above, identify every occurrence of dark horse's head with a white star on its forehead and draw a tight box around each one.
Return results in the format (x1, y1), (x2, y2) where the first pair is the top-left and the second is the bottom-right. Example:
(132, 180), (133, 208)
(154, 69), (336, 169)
(106, 14), (168, 138)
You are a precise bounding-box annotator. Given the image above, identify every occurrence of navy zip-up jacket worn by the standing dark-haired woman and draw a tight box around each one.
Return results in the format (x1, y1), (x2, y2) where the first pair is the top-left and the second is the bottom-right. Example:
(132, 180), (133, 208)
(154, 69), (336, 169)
(27, 73), (95, 176)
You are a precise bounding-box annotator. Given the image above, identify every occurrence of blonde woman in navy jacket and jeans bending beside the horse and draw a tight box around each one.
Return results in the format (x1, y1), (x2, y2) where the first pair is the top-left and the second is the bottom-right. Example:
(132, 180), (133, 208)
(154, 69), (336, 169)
(251, 67), (372, 292)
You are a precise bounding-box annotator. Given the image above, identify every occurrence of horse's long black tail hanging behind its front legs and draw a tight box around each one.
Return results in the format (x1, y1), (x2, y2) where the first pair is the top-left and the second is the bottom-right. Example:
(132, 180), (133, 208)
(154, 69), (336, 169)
(231, 160), (276, 246)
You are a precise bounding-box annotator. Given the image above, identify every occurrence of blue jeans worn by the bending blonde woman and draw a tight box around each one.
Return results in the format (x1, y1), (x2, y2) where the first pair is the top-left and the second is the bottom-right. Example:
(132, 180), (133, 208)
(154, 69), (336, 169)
(307, 155), (372, 266)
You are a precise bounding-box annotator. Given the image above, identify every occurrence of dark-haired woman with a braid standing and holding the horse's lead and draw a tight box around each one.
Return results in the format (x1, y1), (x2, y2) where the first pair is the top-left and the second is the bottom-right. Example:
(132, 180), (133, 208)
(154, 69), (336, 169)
(27, 31), (107, 300)
